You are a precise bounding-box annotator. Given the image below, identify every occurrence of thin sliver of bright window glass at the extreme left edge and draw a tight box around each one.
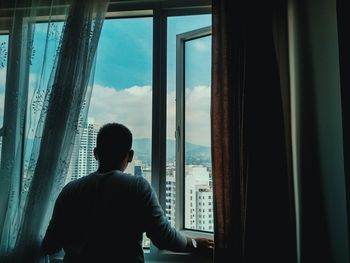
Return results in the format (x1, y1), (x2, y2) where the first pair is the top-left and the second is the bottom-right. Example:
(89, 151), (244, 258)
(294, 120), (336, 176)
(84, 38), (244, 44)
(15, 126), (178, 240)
(0, 35), (9, 162)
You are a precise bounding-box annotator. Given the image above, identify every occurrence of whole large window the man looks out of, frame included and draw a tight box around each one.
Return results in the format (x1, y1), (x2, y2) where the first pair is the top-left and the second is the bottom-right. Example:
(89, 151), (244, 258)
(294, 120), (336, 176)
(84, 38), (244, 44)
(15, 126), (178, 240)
(0, 1), (212, 262)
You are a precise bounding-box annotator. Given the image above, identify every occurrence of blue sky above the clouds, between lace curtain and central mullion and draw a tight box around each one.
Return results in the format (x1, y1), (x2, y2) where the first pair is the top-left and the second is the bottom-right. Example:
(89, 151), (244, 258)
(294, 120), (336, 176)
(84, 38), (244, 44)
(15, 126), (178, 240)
(95, 18), (152, 89)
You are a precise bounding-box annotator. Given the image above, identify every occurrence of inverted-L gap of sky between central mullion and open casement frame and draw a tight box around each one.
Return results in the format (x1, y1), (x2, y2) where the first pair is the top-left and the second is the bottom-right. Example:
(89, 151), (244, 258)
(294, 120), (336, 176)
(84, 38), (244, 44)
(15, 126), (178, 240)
(165, 15), (211, 229)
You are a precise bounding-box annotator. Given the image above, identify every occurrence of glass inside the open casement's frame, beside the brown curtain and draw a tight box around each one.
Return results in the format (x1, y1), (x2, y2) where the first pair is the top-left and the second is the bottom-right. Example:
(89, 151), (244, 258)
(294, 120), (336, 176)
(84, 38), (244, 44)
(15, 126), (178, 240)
(184, 36), (214, 231)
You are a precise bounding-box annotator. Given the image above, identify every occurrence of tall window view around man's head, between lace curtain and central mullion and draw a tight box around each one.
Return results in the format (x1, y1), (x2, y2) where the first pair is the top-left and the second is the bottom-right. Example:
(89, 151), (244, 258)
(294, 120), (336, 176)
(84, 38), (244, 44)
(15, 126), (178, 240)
(67, 17), (153, 248)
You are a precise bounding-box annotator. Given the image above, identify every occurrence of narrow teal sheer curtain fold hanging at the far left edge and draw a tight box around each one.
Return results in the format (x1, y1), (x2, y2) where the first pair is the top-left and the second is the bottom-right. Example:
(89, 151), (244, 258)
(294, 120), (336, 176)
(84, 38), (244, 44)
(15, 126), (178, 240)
(0, 3), (33, 255)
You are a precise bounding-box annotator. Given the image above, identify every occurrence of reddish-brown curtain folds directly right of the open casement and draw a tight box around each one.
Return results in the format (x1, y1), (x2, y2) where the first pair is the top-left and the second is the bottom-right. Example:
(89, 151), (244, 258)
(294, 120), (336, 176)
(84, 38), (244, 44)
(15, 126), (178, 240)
(211, 1), (247, 262)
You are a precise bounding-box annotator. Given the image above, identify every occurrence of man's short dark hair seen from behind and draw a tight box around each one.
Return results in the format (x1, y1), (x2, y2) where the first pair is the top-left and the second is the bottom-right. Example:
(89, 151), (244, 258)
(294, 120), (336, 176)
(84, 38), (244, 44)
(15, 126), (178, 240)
(96, 123), (132, 164)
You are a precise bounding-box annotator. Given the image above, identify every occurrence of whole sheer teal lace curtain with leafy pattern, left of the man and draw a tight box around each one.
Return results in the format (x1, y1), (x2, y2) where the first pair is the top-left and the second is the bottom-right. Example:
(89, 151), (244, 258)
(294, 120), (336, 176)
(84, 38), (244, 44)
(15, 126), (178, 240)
(0, 0), (108, 262)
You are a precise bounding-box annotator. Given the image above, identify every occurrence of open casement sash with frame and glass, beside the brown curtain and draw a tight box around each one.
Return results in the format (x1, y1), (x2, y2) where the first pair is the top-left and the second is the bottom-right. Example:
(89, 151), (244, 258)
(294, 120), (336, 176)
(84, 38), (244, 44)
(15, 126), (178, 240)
(176, 27), (214, 232)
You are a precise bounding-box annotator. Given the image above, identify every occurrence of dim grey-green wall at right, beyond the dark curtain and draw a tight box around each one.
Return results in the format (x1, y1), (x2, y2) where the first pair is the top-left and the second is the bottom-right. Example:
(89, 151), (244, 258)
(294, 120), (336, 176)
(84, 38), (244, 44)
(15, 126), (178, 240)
(289, 0), (349, 263)
